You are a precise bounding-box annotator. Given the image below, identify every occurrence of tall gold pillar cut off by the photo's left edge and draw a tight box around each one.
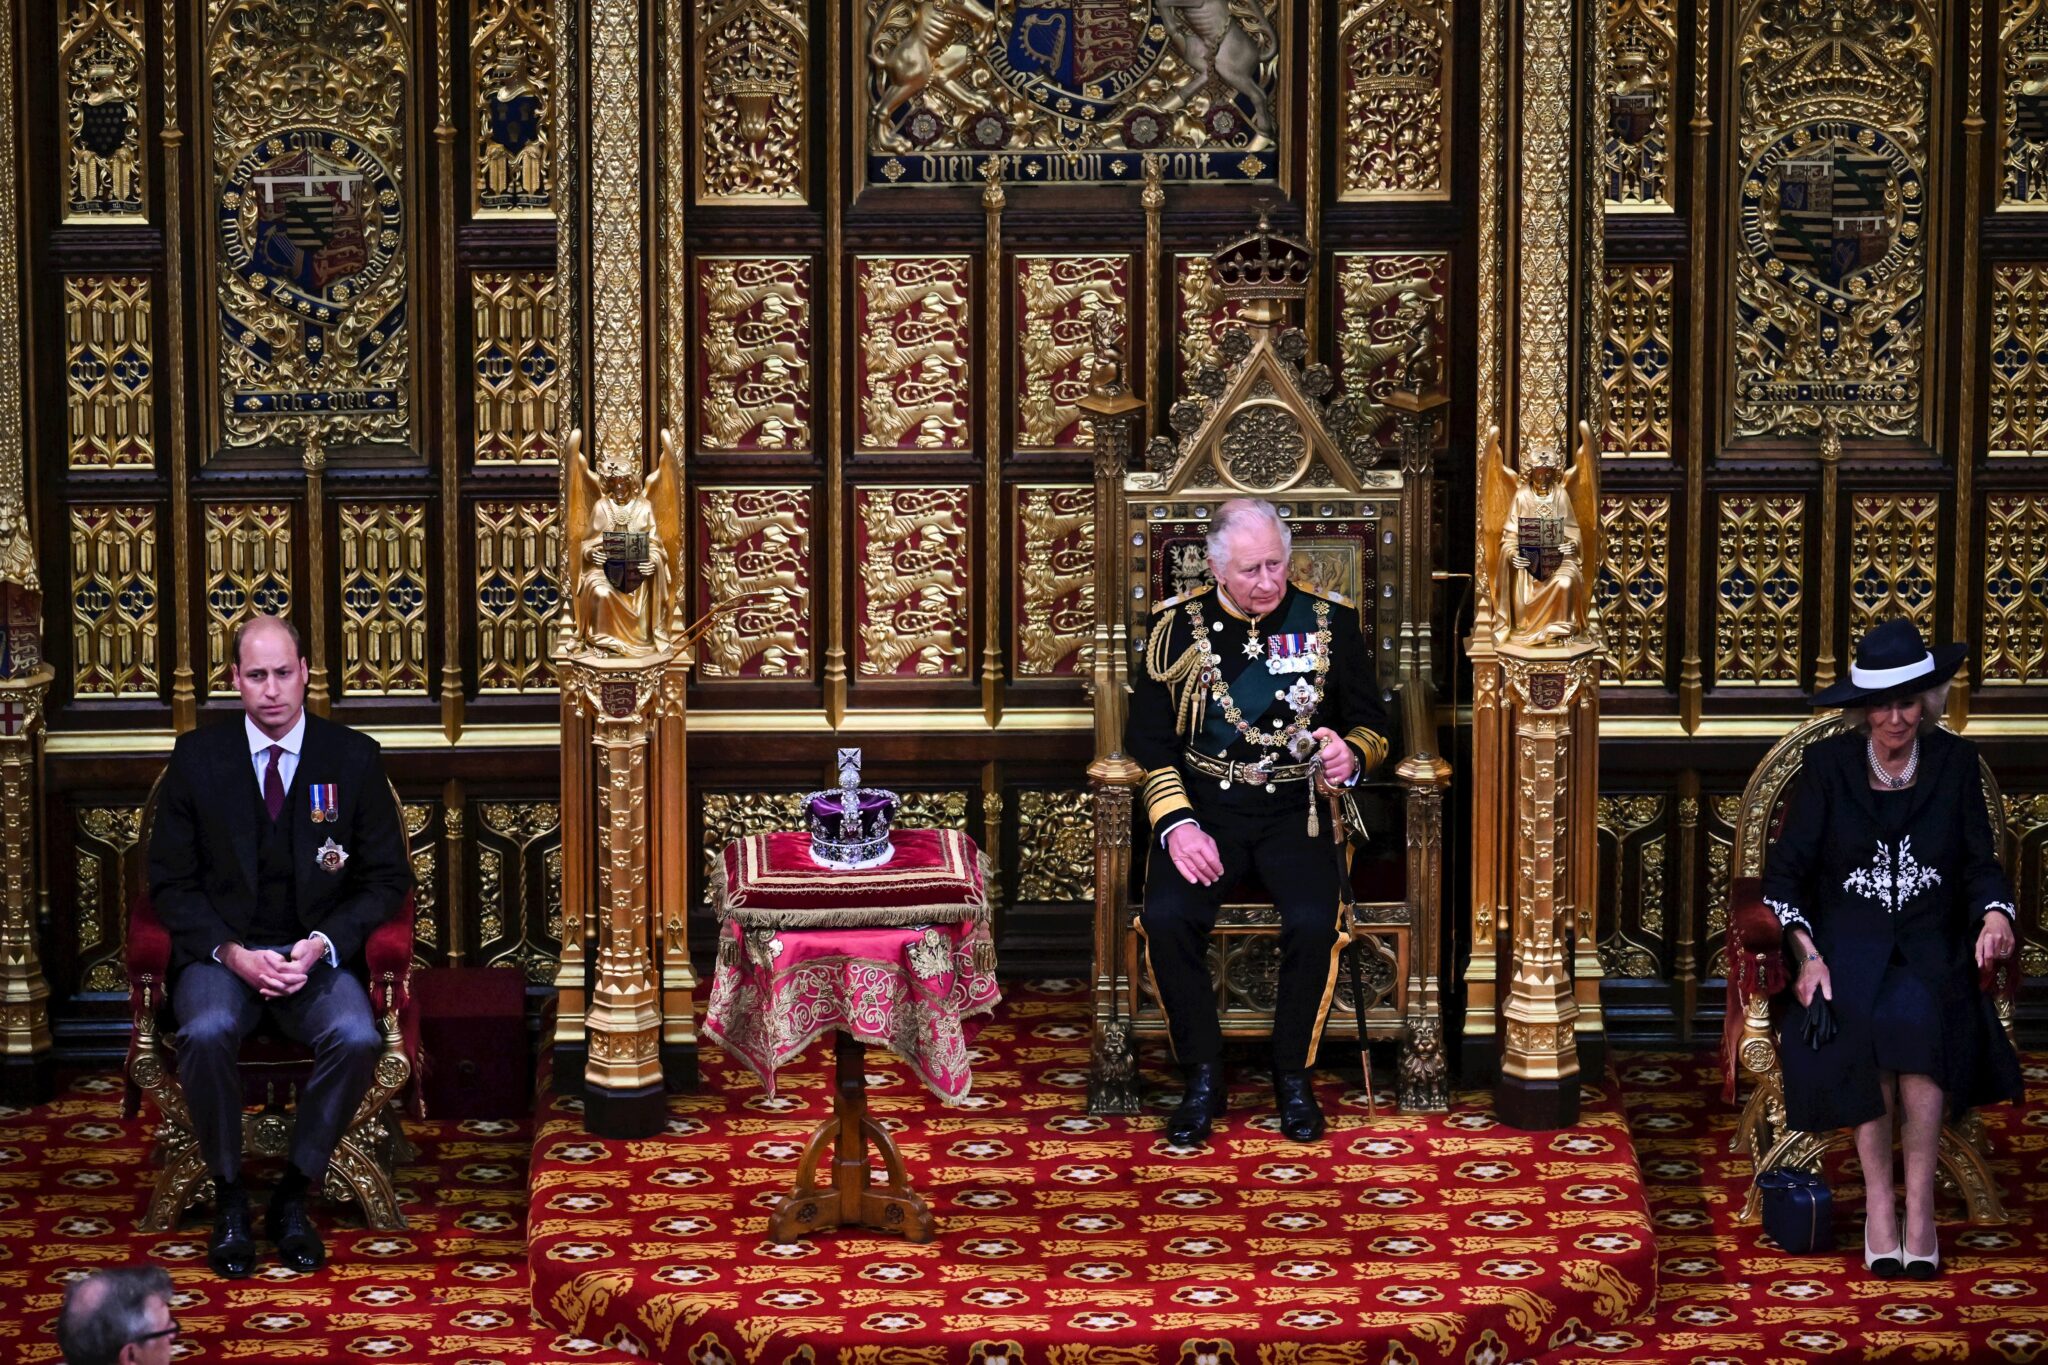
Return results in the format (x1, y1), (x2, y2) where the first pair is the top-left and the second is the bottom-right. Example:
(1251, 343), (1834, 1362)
(0, 6), (51, 1099)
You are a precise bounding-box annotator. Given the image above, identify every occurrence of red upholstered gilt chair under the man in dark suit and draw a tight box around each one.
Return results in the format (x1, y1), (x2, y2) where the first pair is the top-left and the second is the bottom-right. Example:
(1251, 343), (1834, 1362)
(127, 782), (420, 1232)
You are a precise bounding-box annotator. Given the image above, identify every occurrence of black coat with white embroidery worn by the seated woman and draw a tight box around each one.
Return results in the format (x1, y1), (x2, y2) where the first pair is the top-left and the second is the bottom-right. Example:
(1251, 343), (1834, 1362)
(1763, 731), (2021, 1132)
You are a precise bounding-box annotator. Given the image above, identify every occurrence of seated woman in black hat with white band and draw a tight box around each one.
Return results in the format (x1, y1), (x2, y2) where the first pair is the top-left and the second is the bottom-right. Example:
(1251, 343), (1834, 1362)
(1763, 620), (2021, 1279)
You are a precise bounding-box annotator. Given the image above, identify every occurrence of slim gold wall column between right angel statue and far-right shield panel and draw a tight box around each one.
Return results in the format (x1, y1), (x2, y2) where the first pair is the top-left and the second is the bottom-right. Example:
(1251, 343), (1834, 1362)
(1677, 0), (1714, 735)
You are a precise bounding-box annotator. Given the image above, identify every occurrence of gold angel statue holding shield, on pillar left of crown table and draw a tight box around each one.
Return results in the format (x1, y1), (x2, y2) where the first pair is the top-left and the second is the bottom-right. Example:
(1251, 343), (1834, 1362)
(567, 430), (682, 657)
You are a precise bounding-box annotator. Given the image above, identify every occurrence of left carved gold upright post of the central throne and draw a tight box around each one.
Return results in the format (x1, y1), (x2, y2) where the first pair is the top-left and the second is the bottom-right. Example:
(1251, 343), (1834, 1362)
(1081, 323), (1145, 1113)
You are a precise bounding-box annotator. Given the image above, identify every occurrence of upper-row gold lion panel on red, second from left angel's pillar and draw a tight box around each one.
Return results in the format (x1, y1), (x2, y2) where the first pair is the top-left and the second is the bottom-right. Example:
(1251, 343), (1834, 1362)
(854, 256), (975, 450)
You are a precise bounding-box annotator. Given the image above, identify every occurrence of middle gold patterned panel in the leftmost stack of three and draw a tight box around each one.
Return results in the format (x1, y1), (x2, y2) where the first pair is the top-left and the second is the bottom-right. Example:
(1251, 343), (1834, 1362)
(63, 274), (156, 469)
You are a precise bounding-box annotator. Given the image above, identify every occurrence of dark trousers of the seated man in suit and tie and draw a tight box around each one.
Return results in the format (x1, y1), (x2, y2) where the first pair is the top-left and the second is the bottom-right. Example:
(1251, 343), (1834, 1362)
(172, 961), (383, 1187)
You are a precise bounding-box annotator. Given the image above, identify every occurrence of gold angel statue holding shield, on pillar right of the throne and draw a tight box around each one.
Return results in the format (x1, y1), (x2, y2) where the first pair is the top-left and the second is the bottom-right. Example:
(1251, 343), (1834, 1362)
(1481, 422), (1599, 645)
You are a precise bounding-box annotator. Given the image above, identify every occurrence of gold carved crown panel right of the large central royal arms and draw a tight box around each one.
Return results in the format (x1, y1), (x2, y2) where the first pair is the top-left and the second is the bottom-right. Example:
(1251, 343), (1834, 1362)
(1337, 0), (1452, 199)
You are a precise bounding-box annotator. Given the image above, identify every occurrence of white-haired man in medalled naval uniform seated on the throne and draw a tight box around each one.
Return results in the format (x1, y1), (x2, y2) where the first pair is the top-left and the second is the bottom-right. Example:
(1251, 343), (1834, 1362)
(1124, 497), (1386, 1146)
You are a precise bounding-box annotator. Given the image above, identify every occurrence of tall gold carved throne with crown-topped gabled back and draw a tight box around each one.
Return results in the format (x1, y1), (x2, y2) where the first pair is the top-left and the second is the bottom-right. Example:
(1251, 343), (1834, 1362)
(1083, 221), (1450, 1113)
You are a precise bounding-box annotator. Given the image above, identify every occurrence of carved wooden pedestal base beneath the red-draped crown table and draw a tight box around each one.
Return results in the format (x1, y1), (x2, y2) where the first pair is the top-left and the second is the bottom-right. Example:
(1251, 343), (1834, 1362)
(768, 1031), (932, 1242)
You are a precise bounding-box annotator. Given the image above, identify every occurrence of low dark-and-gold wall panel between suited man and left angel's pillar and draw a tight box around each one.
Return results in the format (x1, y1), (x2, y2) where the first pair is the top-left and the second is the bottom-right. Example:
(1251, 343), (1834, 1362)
(471, 800), (561, 986)
